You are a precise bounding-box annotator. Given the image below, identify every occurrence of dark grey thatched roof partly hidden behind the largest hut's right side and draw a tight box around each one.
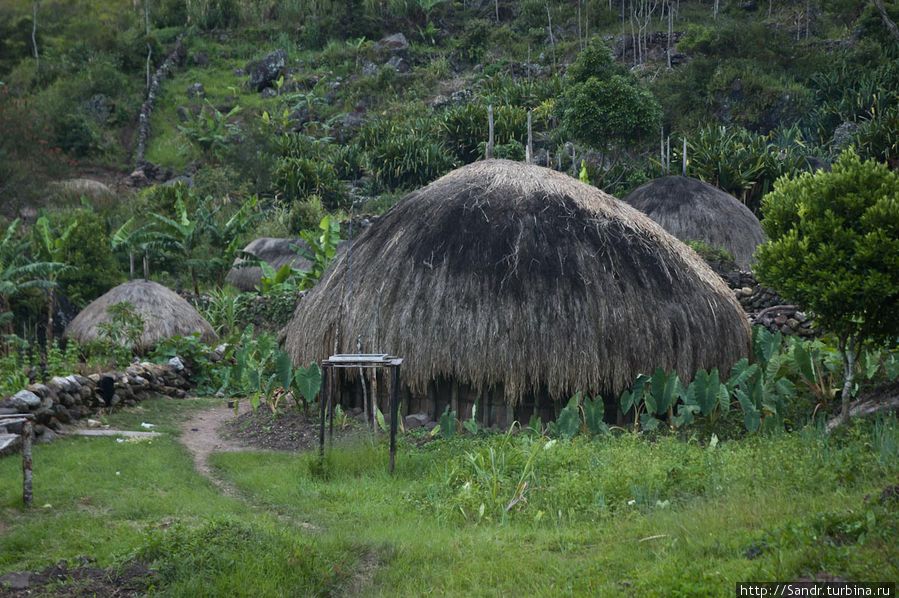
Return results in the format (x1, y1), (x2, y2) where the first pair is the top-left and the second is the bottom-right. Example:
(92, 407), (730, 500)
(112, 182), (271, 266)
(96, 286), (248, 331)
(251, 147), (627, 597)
(624, 176), (765, 270)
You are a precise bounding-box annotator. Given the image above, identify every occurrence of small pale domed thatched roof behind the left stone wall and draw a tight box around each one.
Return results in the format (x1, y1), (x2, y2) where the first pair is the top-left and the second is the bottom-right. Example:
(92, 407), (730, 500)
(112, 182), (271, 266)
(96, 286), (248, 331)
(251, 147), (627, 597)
(66, 280), (216, 350)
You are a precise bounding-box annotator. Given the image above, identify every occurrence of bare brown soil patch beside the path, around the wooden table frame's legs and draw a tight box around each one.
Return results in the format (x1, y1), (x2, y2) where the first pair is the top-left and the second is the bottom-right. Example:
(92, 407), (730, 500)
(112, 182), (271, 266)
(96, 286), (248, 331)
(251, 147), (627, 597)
(222, 408), (366, 451)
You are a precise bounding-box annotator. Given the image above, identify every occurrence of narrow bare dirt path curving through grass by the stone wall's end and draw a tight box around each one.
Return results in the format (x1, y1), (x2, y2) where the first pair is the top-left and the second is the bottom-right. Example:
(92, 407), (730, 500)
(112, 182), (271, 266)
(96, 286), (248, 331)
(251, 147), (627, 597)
(181, 401), (253, 498)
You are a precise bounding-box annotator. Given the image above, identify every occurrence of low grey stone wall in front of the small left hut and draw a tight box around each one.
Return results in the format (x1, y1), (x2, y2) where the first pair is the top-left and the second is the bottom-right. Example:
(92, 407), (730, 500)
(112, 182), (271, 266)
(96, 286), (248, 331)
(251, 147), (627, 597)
(0, 357), (192, 442)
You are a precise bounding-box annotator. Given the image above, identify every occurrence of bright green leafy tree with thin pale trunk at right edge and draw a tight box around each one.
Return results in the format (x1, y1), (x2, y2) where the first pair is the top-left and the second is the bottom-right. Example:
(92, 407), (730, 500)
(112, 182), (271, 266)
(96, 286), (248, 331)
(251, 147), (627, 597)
(756, 149), (899, 423)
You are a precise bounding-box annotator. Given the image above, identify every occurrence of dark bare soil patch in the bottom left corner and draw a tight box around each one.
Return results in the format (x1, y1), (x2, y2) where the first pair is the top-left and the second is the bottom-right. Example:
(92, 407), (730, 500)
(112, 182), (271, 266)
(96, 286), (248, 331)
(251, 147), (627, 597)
(0, 558), (157, 597)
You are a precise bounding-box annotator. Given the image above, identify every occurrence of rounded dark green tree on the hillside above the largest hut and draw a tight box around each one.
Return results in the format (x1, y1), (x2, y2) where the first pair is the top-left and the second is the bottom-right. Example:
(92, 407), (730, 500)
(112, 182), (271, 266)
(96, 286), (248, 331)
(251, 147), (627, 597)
(557, 42), (661, 159)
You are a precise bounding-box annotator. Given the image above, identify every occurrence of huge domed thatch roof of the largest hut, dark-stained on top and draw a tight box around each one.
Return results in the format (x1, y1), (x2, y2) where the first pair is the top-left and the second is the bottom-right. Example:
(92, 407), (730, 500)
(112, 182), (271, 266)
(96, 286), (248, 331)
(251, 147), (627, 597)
(284, 160), (750, 405)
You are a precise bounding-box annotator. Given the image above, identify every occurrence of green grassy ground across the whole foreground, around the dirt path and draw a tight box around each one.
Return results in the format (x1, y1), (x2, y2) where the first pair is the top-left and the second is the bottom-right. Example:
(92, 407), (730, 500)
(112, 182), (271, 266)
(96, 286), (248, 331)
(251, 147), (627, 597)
(0, 400), (899, 596)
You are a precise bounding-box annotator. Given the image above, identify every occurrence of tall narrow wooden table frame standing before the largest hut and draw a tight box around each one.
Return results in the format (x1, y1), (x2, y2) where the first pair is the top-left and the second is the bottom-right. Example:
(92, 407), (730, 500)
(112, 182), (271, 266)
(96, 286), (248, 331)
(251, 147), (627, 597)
(318, 353), (403, 473)
